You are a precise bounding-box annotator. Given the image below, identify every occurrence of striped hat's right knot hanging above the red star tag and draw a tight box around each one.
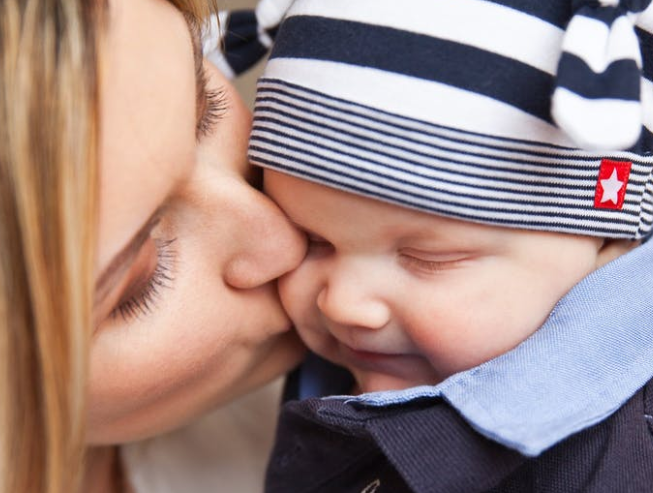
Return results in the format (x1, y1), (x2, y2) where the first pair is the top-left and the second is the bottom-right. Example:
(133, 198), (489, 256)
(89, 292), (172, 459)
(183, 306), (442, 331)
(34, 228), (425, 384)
(551, 0), (653, 150)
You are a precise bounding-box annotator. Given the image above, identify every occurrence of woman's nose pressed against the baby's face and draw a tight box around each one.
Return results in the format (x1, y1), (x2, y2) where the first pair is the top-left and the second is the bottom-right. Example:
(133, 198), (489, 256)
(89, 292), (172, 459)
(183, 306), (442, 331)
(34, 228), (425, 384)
(224, 189), (306, 289)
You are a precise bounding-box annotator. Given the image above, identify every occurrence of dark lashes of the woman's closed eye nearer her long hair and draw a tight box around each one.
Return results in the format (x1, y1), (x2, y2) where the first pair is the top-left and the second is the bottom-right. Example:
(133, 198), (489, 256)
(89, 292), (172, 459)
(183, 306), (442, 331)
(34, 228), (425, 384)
(111, 238), (176, 322)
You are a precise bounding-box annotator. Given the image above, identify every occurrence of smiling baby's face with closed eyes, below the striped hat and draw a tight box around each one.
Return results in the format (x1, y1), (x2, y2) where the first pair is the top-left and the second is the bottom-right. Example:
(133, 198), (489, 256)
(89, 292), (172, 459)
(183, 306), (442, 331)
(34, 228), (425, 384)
(265, 171), (602, 392)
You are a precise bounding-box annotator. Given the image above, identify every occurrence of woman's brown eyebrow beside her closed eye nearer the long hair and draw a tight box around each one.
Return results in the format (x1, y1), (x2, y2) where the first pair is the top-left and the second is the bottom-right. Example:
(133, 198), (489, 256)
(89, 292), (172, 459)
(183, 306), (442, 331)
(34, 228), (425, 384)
(94, 208), (161, 307)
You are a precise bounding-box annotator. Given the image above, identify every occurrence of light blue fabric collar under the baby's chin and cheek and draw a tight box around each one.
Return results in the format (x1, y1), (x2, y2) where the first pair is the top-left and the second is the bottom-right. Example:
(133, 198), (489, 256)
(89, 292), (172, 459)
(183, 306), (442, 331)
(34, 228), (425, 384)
(335, 241), (653, 456)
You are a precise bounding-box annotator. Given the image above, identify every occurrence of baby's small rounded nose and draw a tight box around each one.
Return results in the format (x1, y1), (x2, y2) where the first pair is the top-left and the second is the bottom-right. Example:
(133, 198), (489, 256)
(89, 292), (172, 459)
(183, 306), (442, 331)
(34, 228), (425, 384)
(317, 265), (391, 329)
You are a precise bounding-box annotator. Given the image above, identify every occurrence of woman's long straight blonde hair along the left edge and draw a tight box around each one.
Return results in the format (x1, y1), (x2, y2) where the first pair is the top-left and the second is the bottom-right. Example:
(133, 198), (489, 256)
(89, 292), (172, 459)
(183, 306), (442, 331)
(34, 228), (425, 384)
(0, 0), (215, 493)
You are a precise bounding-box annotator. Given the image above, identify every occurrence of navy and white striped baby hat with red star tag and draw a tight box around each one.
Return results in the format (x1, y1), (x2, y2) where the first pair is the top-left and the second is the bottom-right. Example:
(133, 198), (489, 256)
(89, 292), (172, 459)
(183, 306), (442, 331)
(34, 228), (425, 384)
(249, 0), (653, 239)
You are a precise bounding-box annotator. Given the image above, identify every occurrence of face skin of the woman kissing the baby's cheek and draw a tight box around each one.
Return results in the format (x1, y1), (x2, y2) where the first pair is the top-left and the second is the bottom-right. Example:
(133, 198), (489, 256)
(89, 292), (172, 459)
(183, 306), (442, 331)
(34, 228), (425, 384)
(88, 0), (305, 445)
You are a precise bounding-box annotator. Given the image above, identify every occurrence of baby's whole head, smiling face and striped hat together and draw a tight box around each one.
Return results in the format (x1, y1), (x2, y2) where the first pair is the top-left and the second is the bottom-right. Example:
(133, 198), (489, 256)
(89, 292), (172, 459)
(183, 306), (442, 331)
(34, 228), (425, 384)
(250, 0), (653, 391)
